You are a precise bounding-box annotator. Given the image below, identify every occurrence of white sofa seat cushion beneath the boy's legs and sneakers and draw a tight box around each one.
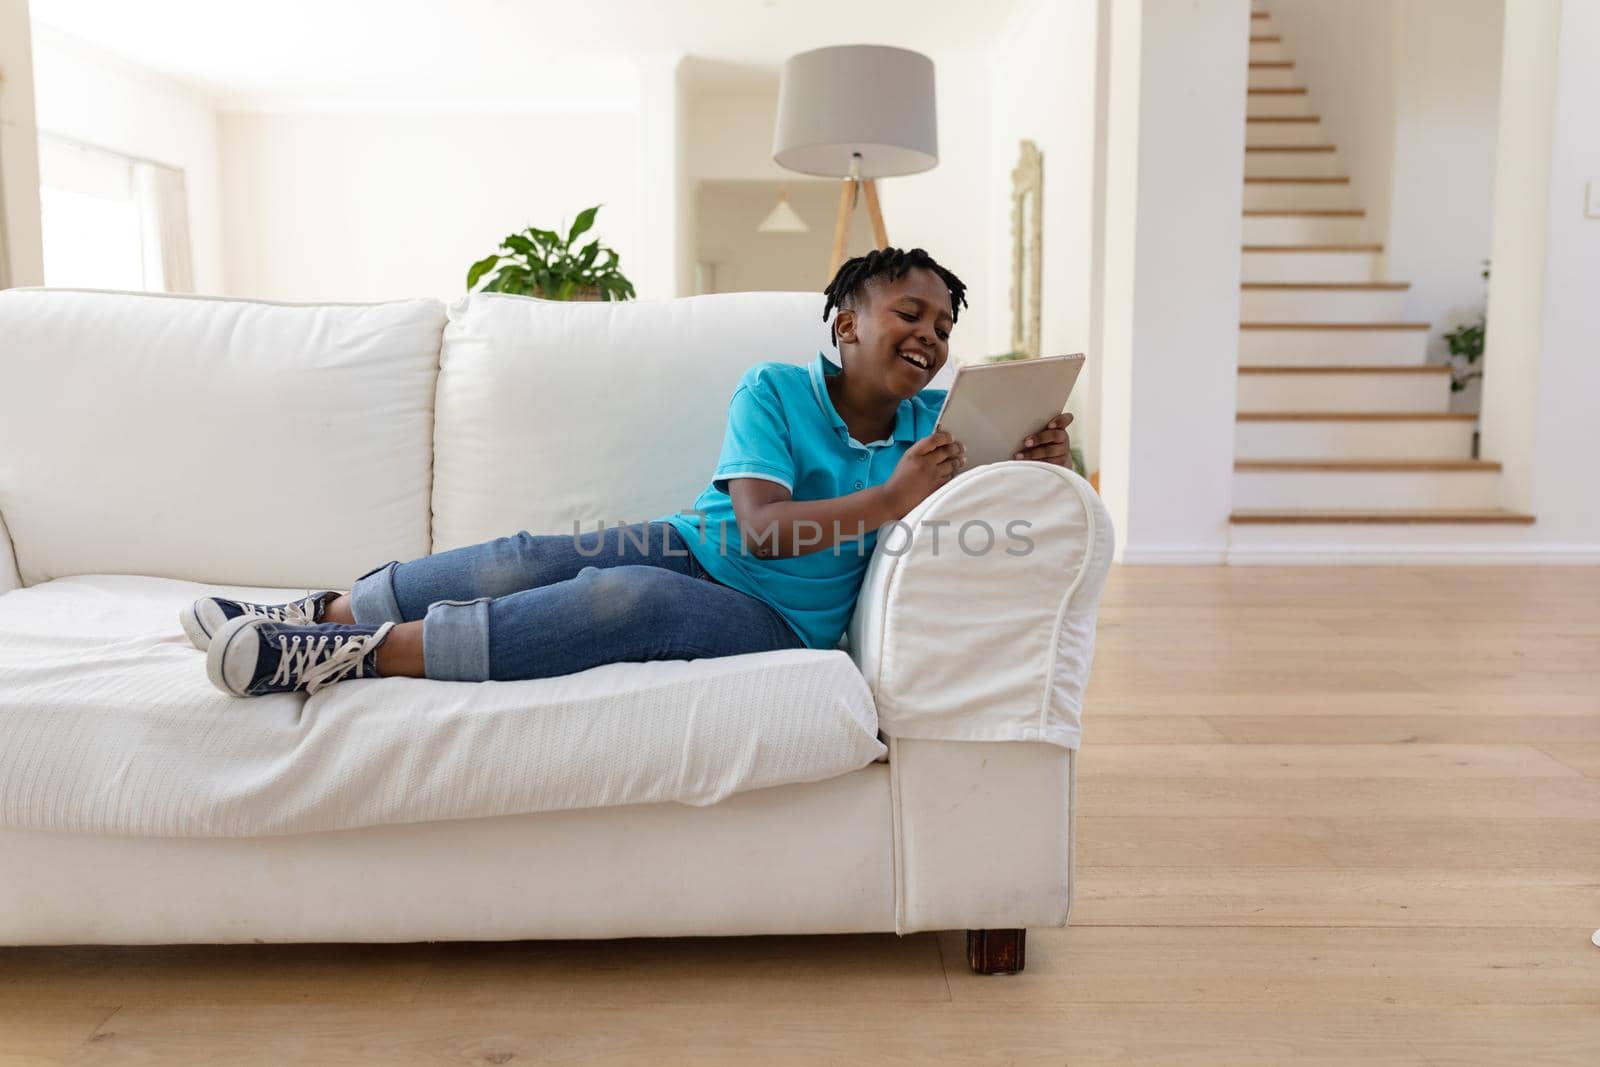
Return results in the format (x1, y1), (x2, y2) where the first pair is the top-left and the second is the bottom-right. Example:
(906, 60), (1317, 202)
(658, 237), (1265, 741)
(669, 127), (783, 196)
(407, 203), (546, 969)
(0, 574), (885, 837)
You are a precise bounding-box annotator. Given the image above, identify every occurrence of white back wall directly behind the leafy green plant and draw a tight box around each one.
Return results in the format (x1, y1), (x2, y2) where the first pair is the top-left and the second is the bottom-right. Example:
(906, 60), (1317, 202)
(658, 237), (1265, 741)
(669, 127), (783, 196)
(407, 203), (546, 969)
(221, 106), (640, 301)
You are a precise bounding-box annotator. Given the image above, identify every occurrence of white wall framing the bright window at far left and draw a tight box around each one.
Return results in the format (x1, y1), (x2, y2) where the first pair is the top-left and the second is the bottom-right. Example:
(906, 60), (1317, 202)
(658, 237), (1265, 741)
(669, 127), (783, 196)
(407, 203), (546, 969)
(34, 26), (227, 293)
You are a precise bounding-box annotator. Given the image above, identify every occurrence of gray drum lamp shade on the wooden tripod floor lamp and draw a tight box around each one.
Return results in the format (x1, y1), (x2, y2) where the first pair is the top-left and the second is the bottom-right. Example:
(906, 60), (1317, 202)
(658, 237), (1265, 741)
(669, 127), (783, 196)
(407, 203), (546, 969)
(773, 45), (939, 178)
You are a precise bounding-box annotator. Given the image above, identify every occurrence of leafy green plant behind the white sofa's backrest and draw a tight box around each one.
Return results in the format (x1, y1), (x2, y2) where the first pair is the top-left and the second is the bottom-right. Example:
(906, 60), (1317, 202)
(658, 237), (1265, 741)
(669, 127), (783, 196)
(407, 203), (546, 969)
(467, 203), (634, 301)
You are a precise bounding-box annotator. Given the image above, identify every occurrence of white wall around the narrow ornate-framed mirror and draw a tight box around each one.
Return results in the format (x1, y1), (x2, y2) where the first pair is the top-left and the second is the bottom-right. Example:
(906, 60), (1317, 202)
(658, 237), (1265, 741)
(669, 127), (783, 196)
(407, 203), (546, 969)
(984, 0), (1101, 470)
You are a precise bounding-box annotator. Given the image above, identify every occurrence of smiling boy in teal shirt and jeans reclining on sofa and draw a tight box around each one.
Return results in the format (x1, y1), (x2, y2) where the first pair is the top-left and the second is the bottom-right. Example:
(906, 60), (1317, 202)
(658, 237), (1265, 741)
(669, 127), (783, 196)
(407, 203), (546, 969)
(181, 248), (1072, 696)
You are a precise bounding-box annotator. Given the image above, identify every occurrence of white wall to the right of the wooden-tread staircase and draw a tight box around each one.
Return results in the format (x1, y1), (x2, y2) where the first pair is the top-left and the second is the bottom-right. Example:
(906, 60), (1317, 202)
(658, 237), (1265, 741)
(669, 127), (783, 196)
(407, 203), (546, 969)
(1483, 0), (1600, 561)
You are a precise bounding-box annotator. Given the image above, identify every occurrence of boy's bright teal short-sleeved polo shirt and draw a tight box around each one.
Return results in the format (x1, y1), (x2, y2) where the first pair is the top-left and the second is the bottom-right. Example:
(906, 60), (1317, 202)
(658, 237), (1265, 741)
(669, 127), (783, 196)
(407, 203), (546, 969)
(653, 352), (947, 648)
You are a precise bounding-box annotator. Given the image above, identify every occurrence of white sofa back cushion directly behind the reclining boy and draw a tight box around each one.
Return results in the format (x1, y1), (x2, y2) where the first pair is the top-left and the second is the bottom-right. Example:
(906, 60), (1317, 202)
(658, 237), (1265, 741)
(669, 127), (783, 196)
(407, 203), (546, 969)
(434, 293), (837, 550)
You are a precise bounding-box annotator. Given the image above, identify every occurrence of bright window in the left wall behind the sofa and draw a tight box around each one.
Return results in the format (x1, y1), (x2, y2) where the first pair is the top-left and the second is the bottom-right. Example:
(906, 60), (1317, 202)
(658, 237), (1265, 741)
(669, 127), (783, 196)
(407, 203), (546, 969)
(38, 133), (194, 293)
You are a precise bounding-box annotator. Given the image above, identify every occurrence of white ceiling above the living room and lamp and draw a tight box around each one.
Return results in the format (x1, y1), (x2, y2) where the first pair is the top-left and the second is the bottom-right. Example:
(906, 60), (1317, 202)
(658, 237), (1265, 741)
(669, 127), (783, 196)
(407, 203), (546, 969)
(30, 0), (1026, 107)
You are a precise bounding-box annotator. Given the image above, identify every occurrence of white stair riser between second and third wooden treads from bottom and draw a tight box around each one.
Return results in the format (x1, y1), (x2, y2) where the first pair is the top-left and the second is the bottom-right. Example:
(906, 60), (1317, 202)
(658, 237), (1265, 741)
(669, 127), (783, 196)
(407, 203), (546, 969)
(1234, 419), (1472, 459)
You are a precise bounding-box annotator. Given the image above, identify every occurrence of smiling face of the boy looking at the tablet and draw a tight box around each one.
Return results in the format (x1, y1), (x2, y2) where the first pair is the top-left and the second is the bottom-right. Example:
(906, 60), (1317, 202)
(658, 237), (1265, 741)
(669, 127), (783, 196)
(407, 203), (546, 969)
(834, 267), (954, 398)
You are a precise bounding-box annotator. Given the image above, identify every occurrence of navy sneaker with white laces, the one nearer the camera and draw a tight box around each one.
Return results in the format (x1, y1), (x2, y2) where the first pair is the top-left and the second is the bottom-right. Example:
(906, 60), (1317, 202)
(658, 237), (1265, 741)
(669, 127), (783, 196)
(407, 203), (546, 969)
(205, 614), (395, 696)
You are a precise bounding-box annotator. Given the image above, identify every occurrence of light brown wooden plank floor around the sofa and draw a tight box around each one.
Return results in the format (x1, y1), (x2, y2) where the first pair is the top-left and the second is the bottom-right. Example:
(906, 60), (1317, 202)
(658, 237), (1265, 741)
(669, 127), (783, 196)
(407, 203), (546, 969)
(0, 568), (1600, 1067)
